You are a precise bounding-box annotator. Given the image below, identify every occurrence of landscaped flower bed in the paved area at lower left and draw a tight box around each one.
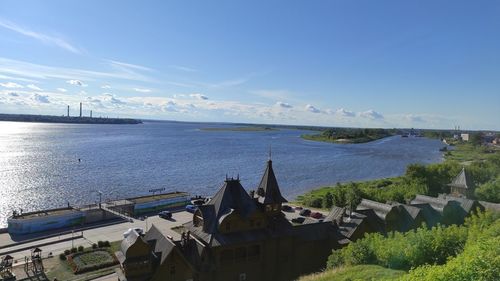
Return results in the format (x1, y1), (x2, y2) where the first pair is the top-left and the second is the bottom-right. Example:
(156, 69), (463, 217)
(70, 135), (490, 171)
(68, 249), (118, 274)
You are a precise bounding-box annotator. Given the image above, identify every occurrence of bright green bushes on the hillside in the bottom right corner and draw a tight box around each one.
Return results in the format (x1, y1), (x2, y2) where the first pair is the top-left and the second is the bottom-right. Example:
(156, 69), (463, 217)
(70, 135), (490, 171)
(328, 212), (500, 280)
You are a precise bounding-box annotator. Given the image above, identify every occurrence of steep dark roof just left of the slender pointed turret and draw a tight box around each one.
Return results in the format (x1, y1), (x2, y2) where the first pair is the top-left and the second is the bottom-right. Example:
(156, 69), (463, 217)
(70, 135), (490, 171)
(199, 179), (257, 233)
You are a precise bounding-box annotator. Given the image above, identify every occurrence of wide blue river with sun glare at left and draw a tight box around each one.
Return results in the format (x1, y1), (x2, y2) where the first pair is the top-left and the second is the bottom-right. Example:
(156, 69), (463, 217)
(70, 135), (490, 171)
(0, 122), (442, 226)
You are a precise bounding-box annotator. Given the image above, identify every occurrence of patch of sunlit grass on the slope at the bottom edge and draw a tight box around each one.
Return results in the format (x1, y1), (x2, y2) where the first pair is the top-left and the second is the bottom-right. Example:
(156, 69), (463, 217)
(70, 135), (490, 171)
(298, 265), (406, 281)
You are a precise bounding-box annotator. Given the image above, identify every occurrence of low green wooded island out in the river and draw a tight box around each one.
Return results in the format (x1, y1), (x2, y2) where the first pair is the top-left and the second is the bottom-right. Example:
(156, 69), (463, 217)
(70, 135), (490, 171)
(301, 128), (396, 143)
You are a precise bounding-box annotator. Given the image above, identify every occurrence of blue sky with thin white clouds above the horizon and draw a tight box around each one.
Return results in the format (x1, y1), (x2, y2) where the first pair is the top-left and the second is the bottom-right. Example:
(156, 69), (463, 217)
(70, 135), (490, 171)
(0, 0), (500, 130)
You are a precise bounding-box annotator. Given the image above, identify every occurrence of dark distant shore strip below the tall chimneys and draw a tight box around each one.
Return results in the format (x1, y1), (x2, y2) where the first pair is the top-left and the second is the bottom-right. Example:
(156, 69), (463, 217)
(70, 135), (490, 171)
(0, 113), (142, 124)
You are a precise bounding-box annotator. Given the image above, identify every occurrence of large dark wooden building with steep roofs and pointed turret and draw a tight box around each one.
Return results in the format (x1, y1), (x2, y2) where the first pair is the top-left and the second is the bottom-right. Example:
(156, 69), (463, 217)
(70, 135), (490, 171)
(118, 160), (342, 281)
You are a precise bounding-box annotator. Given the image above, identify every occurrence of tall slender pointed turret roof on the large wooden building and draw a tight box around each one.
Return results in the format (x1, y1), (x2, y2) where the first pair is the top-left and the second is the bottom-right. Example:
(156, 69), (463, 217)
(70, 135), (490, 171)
(256, 159), (288, 204)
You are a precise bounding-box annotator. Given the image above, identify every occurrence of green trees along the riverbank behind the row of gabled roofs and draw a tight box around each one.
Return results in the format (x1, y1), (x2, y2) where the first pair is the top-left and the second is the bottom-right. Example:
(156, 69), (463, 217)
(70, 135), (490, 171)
(297, 145), (500, 208)
